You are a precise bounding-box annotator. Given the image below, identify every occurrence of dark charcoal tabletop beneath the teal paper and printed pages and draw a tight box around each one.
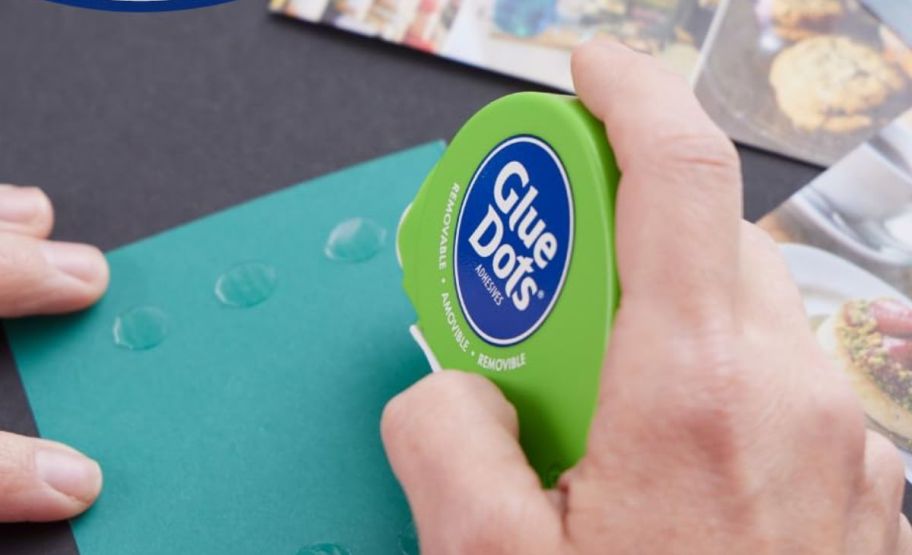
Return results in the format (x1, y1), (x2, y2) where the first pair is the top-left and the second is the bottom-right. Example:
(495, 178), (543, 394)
(0, 0), (844, 555)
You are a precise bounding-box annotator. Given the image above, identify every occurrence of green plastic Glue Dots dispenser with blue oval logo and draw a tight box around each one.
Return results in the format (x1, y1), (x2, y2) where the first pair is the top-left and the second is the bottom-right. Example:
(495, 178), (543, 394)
(398, 93), (620, 485)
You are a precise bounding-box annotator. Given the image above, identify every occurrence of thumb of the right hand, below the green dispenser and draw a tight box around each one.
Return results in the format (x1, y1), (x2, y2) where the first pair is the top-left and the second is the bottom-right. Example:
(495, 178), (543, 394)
(382, 372), (562, 553)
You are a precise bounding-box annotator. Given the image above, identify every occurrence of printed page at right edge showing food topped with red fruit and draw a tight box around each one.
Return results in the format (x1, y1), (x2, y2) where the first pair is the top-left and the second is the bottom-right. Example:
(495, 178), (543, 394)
(760, 107), (912, 480)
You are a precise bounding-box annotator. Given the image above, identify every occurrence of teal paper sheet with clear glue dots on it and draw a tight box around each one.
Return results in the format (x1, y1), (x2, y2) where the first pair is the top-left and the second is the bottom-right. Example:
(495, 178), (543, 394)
(5, 142), (444, 555)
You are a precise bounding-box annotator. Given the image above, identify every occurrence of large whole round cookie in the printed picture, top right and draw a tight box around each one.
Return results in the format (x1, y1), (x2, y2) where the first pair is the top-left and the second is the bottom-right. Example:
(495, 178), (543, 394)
(769, 35), (906, 133)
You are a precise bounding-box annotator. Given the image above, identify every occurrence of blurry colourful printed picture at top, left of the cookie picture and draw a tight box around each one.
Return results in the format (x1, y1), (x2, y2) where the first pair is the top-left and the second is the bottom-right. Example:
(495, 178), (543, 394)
(270, 0), (718, 91)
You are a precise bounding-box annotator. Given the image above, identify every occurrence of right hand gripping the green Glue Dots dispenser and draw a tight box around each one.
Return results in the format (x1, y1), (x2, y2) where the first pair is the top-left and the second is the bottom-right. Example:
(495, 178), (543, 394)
(382, 42), (912, 555)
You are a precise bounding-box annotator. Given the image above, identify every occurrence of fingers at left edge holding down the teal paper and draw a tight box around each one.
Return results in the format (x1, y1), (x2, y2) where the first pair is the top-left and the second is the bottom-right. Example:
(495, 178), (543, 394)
(0, 185), (108, 522)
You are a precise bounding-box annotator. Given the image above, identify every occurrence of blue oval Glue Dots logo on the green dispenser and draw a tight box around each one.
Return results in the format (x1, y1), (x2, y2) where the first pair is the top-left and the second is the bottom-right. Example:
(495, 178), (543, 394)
(453, 136), (573, 347)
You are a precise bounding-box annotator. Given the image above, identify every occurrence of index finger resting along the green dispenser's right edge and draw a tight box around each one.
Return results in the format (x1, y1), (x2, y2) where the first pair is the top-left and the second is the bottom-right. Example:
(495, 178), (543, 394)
(573, 41), (741, 323)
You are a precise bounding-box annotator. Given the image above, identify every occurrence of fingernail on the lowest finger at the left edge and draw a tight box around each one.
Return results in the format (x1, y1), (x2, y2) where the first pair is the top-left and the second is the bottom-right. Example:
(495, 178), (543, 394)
(35, 449), (101, 503)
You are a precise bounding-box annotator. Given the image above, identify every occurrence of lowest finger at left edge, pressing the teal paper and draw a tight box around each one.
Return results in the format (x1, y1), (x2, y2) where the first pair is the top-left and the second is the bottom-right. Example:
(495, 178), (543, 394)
(0, 432), (101, 522)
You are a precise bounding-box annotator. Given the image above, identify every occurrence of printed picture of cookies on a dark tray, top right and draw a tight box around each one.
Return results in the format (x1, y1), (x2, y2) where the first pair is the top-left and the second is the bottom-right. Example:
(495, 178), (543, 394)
(696, 0), (912, 166)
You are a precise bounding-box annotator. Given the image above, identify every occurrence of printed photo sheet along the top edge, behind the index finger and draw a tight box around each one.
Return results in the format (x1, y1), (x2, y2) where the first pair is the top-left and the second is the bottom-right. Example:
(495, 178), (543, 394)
(271, 0), (912, 170)
